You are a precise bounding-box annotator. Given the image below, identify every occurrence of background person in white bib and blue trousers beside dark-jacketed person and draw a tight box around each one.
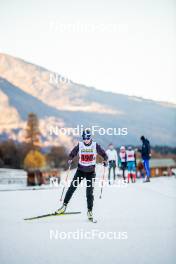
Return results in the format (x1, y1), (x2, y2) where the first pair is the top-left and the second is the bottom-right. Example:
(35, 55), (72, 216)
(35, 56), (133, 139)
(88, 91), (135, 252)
(126, 147), (136, 183)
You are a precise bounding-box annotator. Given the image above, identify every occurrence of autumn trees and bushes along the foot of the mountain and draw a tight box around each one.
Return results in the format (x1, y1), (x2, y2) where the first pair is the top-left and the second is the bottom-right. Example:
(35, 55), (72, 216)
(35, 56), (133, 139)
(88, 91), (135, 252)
(0, 113), (176, 169)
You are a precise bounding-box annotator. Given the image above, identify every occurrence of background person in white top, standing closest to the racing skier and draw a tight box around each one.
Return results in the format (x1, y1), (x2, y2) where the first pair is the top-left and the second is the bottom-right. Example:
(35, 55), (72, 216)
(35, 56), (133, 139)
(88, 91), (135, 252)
(106, 144), (118, 184)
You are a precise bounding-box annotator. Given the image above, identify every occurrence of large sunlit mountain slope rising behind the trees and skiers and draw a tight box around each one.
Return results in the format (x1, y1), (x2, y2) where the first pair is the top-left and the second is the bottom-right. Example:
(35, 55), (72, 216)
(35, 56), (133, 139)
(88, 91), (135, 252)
(0, 54), (176, 145)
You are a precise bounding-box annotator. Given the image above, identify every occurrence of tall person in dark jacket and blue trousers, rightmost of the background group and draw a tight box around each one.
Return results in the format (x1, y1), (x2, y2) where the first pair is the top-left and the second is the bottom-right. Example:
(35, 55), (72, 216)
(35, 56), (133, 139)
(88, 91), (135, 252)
(139, 136), (151, 182)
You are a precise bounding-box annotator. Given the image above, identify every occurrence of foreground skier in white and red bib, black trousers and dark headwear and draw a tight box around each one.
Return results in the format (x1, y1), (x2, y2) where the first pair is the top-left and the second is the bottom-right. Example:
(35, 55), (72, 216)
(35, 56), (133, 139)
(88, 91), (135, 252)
(56, 129), (108, 220)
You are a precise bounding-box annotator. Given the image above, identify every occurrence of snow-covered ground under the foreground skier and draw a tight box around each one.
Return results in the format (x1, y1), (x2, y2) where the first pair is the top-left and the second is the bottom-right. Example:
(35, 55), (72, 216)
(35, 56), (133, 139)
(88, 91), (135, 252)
(0, 168), (176, 264)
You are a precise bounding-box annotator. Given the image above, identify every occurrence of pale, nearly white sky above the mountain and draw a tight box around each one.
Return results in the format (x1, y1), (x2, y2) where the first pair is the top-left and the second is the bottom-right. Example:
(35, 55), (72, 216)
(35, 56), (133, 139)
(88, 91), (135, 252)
(0, 0), (176, 102)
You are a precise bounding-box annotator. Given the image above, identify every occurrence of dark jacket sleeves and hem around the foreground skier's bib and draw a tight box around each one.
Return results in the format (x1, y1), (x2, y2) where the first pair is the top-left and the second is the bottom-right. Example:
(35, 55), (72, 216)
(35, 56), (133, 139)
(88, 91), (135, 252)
(69, 143), (108, 172)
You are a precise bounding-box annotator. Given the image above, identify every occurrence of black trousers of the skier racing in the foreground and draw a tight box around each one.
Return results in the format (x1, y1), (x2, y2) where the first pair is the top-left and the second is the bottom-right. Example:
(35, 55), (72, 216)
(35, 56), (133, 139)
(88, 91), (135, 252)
(64, 170), (95, 210)
